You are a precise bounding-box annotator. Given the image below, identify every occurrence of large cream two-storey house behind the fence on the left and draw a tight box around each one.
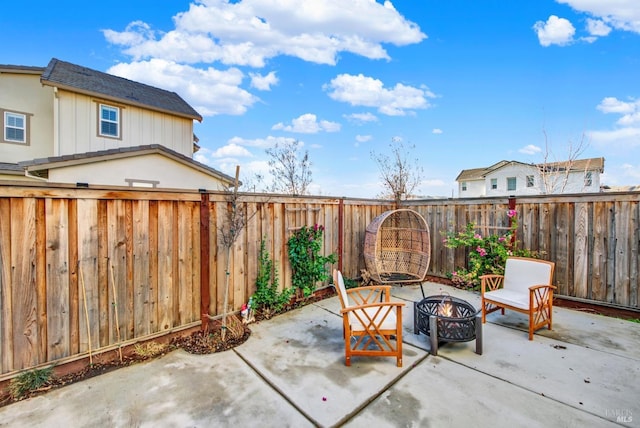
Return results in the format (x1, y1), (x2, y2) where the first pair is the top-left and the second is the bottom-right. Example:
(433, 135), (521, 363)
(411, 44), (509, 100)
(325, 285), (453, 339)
(0, 58), (234, 190)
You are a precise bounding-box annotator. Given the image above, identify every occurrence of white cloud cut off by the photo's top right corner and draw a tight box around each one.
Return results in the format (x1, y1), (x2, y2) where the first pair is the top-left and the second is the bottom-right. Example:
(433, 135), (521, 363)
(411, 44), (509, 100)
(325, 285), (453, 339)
(556, 0), (640, 33)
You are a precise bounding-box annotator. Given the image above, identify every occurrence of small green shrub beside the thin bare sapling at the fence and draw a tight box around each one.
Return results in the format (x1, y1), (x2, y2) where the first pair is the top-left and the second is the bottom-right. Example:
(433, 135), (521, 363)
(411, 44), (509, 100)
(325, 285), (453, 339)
(250, 239), (295, 318)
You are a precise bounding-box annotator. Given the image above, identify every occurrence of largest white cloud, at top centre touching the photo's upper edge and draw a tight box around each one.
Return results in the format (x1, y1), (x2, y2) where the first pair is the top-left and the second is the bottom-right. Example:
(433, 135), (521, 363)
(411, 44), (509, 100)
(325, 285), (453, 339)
(103, 0), (426, 67)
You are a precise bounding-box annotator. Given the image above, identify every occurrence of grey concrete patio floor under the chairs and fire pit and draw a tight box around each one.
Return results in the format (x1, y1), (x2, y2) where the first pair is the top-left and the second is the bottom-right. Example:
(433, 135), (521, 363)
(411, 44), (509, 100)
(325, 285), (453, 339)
(0, 283), (640, 428)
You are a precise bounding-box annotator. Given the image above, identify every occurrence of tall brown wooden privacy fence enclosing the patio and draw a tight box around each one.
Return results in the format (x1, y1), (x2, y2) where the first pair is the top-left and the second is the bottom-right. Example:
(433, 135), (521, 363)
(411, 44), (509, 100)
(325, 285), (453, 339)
(0, 182), (640, 377)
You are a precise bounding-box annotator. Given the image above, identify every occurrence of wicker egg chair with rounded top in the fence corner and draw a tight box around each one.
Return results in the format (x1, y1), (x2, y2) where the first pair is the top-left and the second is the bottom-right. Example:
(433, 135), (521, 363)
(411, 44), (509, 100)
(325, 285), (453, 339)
(364, 209), (431, 284)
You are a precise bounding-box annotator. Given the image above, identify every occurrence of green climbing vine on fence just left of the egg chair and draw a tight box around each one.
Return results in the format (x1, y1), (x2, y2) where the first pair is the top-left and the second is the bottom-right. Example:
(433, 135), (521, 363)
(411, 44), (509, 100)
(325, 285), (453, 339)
(287, 224), (337, 297)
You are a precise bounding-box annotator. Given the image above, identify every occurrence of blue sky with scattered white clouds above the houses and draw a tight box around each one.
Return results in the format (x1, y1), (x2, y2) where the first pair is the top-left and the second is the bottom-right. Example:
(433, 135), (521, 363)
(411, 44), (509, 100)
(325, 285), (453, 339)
(0, 0), (640, 197)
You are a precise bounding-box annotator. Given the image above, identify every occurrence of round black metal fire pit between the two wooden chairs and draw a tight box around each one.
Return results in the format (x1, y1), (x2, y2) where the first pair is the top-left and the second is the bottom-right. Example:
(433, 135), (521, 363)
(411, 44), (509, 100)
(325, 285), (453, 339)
(413, 294), (482, 355)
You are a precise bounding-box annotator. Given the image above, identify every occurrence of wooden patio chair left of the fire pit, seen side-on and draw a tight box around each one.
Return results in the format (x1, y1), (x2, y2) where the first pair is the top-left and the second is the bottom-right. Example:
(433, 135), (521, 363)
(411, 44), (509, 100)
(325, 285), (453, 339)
(333, 270), (404, 367)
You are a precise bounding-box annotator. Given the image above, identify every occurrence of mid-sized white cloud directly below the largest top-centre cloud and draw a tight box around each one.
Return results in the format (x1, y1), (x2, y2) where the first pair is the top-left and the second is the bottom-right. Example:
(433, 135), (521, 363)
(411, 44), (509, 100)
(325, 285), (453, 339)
(323, 74), (435, 116)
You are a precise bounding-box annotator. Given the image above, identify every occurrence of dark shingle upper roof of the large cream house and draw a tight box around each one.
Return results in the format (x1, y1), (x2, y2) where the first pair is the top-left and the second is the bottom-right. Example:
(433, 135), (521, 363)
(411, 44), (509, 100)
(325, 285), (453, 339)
(40, 58), (202, 121)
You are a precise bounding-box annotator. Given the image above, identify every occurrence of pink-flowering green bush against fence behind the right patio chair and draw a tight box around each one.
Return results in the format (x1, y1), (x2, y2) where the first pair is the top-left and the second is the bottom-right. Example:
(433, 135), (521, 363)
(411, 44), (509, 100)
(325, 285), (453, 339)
(441, 210), (538, 289)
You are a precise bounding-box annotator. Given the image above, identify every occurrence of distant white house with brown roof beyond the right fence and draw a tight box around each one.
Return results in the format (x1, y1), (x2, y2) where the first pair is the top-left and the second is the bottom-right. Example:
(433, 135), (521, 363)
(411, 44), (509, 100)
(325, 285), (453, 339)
(456, 158), (604, 198)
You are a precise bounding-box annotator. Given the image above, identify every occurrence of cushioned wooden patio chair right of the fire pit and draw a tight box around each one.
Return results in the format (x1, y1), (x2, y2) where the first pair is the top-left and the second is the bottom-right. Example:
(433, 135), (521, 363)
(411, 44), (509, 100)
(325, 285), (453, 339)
(480, 257), (556, 340)
